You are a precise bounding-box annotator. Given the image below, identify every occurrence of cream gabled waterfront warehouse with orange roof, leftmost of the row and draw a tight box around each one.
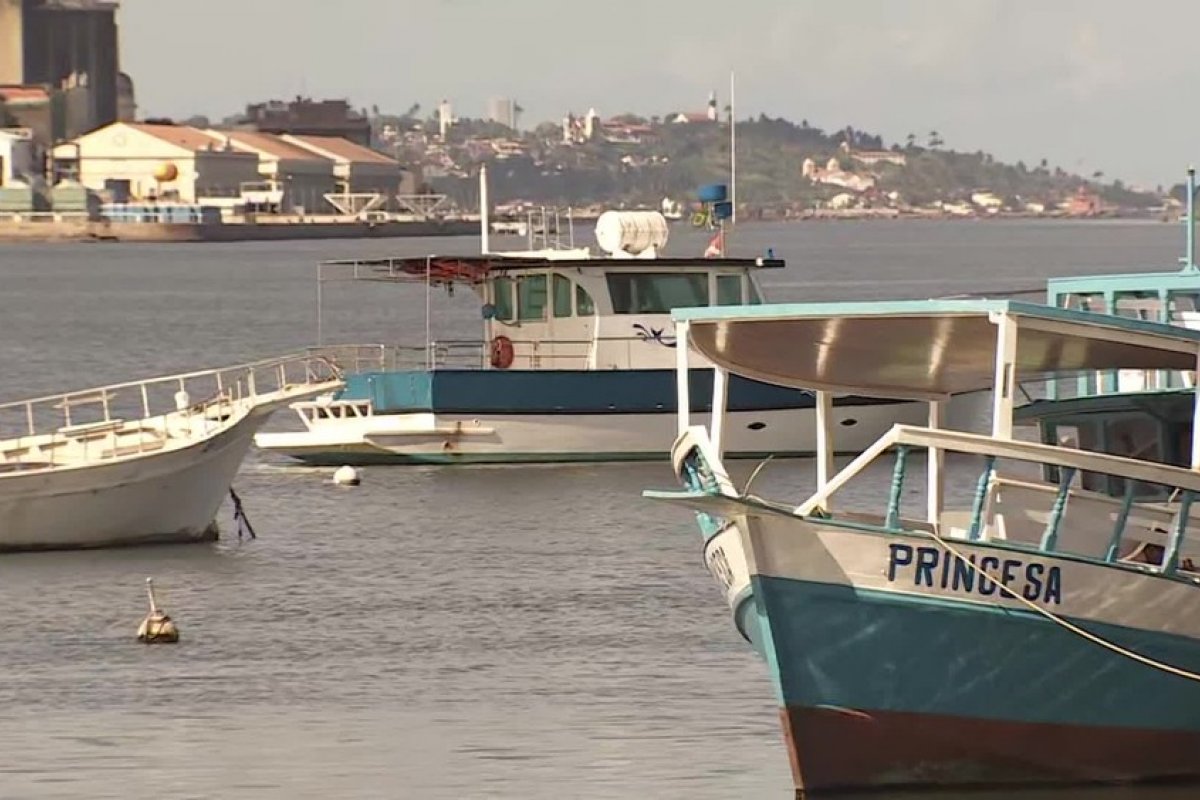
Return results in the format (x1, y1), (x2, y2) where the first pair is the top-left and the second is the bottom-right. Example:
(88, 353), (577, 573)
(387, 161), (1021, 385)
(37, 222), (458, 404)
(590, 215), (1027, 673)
(53, 122), (258, 203)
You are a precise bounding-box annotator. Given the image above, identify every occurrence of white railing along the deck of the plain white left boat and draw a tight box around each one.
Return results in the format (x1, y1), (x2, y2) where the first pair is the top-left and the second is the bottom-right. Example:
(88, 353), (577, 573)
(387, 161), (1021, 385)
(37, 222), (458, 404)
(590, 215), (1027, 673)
(0, 354), (342, 464)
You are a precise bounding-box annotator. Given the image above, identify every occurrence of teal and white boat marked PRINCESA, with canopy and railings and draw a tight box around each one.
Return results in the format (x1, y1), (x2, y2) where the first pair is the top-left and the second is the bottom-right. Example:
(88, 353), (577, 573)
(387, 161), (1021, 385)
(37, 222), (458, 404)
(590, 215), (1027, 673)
(647, 301), (1200, 792)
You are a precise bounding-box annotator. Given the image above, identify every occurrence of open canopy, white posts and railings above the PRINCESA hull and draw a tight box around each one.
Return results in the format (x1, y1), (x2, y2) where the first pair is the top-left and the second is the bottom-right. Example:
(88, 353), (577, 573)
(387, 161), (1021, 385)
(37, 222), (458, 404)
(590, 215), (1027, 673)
(649, 301), (1200, 575)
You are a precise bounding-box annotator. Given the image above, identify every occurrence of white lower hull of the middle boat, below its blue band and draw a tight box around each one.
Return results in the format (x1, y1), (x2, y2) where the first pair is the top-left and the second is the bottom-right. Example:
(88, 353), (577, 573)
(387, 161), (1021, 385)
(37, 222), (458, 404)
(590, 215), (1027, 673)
(256, 403), (926, 465)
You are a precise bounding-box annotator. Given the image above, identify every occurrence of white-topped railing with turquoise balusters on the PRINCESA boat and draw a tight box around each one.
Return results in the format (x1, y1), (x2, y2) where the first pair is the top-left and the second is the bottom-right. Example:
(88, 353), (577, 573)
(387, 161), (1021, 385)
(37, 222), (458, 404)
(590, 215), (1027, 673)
(772, 425), (1200, 575)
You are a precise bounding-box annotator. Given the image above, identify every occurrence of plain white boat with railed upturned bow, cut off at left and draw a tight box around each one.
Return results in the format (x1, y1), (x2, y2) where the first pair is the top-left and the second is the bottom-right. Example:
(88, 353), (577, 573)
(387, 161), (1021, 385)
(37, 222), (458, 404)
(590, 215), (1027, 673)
(0, 355), (342, 551)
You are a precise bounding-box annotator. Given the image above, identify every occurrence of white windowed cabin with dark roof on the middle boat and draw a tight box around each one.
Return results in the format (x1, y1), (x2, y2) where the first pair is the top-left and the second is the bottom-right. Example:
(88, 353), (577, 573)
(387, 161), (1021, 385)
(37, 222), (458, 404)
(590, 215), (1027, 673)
(320, 251), (784, 369)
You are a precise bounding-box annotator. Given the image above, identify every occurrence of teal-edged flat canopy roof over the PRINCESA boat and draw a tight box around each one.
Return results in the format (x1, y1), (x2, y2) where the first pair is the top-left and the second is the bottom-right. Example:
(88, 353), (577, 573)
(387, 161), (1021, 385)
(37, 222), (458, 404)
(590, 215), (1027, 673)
(673, 300), (1200, 399)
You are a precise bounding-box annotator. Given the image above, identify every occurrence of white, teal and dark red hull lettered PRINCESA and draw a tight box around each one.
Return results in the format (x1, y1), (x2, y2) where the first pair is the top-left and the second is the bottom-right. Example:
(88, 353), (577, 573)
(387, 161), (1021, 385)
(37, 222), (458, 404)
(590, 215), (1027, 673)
(706, 515), (1200, 792)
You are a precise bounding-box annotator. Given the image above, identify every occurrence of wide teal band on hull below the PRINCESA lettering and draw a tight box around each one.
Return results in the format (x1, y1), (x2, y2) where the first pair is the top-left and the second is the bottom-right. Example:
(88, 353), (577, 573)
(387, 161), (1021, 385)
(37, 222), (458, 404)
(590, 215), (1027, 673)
(748, 576), (1200, 732)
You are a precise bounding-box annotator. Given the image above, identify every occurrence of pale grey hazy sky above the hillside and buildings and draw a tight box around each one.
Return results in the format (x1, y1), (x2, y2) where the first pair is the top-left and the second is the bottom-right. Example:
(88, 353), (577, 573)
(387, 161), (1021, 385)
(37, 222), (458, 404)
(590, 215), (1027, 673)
(120, 0), (1200, 186)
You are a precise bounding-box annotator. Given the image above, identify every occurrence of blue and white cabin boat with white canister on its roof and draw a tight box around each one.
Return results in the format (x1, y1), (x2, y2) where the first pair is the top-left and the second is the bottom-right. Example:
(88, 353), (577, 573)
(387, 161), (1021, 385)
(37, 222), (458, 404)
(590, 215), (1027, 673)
(256, 173), (922, 465)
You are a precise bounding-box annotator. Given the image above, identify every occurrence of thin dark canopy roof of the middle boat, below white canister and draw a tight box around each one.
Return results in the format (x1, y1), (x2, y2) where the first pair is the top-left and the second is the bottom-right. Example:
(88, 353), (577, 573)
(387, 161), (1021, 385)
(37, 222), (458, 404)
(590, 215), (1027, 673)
(318, 254), (784, 284)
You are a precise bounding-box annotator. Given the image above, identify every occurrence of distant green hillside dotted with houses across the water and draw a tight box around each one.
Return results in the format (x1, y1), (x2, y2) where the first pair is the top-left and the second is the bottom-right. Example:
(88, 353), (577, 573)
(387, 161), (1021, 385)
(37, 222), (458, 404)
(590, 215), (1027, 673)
(372, 102), (1174, 218)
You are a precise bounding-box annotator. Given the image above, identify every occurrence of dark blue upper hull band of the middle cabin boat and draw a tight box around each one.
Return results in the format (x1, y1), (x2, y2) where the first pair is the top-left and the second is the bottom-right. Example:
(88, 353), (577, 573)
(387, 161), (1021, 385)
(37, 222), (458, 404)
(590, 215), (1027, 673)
(341, 369), (900, 415)
